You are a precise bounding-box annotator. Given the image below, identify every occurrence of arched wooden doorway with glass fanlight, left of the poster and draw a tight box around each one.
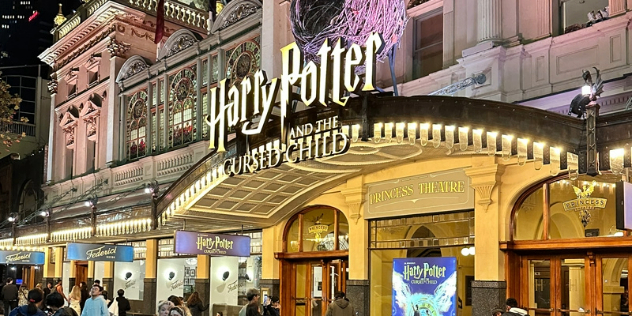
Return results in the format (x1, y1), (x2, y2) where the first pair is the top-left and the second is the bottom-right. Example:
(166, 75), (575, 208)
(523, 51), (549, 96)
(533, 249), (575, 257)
(275, 206), (349, 316)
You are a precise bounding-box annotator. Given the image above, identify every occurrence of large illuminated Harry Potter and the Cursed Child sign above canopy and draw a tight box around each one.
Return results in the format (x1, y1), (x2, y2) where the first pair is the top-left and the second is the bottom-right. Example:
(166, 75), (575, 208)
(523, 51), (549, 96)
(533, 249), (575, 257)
(206, 33), (384, 175)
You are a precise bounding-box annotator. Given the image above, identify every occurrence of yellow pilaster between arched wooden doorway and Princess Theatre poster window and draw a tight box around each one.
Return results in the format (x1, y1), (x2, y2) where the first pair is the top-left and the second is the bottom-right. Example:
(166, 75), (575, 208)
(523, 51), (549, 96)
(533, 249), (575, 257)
(340, 177), (371, 316)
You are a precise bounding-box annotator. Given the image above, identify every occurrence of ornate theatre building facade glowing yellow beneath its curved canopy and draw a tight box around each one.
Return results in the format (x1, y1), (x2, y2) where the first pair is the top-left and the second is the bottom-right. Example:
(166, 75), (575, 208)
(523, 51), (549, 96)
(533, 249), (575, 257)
(0, 0), (632, 316)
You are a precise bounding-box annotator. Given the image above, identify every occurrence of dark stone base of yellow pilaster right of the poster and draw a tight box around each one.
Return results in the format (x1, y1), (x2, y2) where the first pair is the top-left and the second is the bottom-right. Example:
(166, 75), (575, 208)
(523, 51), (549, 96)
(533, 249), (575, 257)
(472, 281), (507, 316)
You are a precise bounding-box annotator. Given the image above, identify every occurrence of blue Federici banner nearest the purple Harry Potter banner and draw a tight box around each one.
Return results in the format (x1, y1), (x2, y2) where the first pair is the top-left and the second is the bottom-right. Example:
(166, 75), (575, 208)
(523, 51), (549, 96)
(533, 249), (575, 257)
(67, 243), (134, 262)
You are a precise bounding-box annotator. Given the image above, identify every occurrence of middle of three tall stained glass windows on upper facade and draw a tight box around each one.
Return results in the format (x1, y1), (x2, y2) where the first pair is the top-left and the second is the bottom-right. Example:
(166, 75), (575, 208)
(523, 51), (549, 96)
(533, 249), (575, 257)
(168, 68), (197, 147)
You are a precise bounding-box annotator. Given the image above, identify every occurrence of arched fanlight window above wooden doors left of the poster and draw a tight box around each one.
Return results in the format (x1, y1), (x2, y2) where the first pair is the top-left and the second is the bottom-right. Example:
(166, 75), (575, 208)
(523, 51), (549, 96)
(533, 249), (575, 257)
(283, 206), (349, 252)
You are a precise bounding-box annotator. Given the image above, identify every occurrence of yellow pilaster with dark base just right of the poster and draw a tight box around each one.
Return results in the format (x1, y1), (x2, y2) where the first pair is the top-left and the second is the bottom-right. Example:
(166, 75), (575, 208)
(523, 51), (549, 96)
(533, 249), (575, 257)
(465, 156), (507, 316)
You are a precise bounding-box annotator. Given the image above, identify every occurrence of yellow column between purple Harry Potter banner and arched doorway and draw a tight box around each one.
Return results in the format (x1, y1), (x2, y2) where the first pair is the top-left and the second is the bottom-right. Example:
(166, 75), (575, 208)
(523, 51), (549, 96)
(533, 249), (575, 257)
(259, 226), (283, 296)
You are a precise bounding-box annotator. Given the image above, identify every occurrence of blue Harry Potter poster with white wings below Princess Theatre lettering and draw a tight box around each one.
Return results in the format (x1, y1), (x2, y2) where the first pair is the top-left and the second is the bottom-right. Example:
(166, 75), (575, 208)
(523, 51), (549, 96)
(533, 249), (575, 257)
(392, 257), (457, 316)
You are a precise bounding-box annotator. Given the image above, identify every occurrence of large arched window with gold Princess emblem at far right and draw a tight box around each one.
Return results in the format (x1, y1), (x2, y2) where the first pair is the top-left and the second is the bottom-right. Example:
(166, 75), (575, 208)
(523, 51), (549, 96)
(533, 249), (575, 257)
(510, 174), (623, 240)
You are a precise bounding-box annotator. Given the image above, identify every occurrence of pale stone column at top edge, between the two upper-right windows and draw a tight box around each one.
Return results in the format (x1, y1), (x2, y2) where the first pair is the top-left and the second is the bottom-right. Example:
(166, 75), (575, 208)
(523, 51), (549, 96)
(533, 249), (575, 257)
(477, 0), (502, 44)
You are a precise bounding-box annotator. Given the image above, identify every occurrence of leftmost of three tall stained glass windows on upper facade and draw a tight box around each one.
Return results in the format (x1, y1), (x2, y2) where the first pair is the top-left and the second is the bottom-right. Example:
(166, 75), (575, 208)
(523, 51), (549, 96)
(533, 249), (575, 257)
(127, 91), (147, 159)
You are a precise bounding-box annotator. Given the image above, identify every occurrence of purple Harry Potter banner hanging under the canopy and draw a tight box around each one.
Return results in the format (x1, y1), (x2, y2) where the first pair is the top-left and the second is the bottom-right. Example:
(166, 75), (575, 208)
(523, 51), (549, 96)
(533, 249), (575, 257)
(175, 230), (250, 257)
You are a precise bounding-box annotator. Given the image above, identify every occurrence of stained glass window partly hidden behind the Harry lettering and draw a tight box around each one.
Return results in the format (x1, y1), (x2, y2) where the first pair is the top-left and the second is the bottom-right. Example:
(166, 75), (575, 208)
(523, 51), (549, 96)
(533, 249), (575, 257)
(226, 37), (261, 83)
